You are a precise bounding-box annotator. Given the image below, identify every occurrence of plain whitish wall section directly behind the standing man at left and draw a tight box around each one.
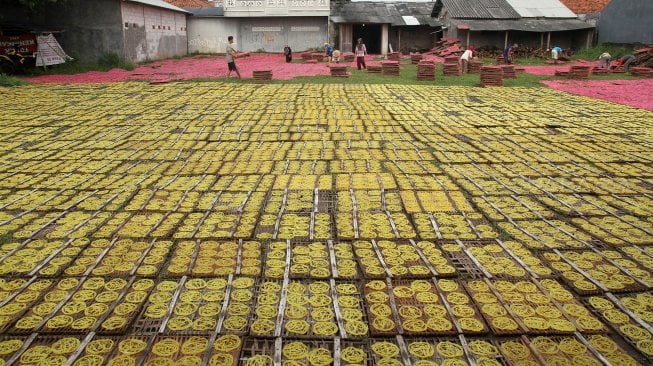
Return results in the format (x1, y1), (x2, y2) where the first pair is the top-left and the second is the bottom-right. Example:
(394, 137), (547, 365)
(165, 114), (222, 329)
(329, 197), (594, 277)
(188, 17), (240, 53)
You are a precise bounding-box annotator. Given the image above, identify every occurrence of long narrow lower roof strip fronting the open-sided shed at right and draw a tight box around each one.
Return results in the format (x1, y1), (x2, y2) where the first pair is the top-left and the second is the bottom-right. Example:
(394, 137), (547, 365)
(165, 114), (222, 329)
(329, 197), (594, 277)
(460, 18), (594, 32)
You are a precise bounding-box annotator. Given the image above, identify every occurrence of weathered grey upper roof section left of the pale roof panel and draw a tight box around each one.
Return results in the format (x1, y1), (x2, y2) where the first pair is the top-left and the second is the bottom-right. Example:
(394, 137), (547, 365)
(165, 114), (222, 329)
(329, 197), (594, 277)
(434, 0), (519, 19)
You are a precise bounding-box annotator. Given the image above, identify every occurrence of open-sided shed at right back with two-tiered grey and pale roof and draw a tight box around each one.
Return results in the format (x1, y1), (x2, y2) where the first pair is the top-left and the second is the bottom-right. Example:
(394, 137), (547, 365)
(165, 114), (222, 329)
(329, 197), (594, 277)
(431, 0), (594, 49)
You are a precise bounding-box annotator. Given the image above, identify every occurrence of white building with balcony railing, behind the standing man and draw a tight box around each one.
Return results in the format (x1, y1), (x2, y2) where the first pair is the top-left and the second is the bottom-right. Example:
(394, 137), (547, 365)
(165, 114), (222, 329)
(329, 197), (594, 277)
(167, 0), (329, 53)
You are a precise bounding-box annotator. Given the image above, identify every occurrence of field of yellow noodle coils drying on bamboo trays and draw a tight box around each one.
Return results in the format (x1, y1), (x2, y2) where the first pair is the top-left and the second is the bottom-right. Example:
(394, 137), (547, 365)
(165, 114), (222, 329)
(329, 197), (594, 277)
(0, 82), (653, 366)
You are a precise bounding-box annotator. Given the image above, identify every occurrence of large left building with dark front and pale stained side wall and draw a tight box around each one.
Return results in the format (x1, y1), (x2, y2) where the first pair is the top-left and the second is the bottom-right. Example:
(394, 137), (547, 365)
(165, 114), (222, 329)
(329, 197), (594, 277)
(0, 0), (188, 63)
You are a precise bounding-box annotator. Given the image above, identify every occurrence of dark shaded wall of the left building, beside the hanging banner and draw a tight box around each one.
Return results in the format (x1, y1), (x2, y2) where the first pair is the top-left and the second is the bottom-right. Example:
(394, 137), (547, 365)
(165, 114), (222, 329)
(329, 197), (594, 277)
(42, 0), (124, 62)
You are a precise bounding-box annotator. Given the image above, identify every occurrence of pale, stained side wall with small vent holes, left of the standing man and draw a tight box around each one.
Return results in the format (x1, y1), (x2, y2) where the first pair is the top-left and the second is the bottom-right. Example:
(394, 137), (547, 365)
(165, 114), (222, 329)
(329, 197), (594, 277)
(121, 2), (188, 62)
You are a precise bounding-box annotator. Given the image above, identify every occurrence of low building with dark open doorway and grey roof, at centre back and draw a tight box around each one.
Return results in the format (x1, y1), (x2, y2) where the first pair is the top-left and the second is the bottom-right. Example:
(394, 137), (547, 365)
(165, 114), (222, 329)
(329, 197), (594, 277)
(330, 1), (440, 54)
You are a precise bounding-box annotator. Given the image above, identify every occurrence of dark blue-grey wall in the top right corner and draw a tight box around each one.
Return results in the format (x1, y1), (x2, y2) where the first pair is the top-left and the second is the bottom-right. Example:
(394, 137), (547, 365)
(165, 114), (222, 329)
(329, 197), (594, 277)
(598, 0), (653, 44)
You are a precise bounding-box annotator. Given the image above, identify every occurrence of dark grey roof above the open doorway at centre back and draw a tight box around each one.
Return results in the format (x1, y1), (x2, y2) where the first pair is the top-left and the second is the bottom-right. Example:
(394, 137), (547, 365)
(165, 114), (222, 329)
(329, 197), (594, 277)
(331, 1), (440, 27)
